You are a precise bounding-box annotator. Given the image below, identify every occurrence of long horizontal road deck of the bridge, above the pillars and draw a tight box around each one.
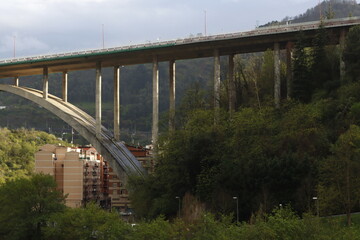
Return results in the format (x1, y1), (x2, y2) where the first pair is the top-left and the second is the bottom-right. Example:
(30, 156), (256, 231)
(0, 17), (360, 78)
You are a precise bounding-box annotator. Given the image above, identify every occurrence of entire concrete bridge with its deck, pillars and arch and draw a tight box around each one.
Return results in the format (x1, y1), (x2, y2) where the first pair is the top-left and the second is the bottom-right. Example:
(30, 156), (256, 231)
(0, 17), (360, 174)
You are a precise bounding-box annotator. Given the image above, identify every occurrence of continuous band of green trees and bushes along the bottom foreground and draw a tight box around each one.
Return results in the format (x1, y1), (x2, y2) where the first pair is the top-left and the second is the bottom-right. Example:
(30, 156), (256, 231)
(0, 174), (360, 240)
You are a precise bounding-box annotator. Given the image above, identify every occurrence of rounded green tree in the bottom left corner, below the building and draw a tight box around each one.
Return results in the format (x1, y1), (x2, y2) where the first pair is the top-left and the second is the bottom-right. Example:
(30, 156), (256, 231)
(0, 174), (65, 239)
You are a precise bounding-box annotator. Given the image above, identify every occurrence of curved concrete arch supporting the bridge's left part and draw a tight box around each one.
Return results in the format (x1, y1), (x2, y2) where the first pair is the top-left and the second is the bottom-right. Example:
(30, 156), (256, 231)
(0, 84), (145, 178)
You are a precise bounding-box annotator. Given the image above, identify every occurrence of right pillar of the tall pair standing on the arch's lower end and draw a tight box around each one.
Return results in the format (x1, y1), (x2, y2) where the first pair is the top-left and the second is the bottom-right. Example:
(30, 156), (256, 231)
(114, 66), (120, 141)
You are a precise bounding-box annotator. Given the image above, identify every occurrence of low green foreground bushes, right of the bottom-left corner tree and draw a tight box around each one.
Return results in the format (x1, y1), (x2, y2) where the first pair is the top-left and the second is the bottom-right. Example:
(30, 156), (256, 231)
(24, 202), (360, 240)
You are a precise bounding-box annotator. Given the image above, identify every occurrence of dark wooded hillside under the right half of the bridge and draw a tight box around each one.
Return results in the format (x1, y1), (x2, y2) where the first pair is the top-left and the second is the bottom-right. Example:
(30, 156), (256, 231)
(130, 24), (360, 227)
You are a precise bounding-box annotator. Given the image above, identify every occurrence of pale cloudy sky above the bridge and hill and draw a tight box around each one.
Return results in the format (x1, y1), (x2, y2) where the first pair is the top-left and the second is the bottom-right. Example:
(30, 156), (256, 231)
(0, 0), (318, 59)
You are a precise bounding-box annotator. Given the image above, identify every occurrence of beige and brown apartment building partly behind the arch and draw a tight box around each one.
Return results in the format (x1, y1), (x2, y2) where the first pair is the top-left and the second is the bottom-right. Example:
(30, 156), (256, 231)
(35, 144), (153, 215)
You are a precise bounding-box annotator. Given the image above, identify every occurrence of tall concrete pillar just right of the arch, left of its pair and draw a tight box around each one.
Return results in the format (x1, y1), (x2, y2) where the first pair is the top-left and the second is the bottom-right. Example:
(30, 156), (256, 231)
(152, 56), (159, 148)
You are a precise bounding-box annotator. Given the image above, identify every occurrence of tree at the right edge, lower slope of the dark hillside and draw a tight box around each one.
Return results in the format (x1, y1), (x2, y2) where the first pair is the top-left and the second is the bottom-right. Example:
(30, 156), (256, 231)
(319, 125), (360, 225)
